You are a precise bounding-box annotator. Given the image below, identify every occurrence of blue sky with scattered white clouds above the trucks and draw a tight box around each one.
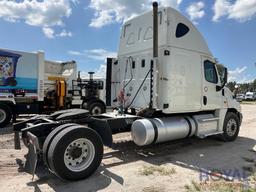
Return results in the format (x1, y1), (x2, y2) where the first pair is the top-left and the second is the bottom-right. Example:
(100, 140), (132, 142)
(0, 0), (256, 83)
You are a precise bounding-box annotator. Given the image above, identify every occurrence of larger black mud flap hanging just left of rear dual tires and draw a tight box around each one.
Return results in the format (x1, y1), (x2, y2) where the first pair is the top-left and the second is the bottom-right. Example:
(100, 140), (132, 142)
(25, 143), (37, 180)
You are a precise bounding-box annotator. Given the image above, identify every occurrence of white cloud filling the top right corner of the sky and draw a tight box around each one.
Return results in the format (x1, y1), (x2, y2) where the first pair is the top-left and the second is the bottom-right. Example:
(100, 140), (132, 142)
(212, 0), (256, 22)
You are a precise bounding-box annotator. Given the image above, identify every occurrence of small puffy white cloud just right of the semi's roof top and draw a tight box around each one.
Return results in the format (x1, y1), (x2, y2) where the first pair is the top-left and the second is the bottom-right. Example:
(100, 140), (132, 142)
(186, 1), (205, 23)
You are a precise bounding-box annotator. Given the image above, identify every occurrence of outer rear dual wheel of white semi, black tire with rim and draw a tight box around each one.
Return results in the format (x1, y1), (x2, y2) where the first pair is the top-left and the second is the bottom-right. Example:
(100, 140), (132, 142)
(48, 126), (103, 181)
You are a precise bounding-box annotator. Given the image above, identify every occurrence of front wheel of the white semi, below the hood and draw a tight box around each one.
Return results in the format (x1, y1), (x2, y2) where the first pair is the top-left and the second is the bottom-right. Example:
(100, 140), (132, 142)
(221, 112), (240, 142)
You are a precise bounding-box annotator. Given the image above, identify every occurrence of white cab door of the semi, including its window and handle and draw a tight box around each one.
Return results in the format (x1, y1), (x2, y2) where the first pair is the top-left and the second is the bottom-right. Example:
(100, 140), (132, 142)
(202, 57), (223, 110)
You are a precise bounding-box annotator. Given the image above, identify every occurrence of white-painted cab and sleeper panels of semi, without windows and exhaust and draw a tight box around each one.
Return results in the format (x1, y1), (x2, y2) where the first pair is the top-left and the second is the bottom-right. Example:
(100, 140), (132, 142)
(111, 8), (240, 121)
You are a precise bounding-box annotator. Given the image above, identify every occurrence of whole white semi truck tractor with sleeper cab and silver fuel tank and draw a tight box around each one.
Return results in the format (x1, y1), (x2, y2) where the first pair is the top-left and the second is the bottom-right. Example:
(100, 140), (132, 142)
(14, 3), (242, 180)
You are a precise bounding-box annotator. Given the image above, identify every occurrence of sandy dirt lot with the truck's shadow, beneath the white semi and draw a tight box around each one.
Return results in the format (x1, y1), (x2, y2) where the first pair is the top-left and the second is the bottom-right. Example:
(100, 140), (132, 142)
(0, 105), (256, 192)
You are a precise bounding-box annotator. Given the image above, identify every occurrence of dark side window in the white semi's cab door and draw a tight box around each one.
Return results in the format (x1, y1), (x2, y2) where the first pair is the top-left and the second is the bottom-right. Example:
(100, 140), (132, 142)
(204, 60), (218, 84)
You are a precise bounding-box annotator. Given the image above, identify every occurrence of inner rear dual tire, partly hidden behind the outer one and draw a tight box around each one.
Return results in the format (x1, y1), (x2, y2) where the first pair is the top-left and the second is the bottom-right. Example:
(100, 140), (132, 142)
(43, 123), (76, 169)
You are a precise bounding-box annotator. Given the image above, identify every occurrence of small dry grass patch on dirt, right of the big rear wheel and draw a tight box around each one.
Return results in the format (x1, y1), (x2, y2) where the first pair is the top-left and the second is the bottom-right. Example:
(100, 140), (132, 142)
(140, 166), (176, 176)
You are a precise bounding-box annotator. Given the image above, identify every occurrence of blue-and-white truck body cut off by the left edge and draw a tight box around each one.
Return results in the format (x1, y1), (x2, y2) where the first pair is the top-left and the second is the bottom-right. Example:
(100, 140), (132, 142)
(0, 49), (44, 127)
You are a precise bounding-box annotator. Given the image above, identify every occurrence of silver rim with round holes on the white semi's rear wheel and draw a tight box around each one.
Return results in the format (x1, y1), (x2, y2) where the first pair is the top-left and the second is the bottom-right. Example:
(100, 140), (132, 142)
(64, 138), (95, 172)
